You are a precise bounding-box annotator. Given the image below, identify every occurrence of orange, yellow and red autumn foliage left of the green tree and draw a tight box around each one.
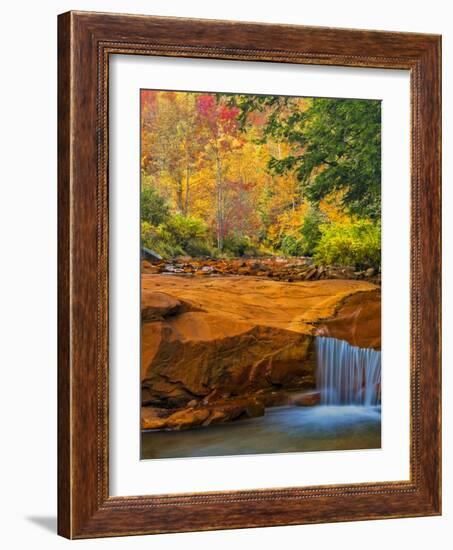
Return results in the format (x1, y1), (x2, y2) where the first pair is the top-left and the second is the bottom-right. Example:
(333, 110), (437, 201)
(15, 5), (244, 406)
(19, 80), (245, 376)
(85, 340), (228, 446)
(141, 90), (344, 254)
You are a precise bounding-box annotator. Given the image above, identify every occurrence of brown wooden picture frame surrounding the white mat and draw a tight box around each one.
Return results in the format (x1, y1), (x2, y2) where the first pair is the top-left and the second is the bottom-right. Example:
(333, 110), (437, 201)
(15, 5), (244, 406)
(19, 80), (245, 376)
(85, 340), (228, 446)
(58, 12), (441, 538)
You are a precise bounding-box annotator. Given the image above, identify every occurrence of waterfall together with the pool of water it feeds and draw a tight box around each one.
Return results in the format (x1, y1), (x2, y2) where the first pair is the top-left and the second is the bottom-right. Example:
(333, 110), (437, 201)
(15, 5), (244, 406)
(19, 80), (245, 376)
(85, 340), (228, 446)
(141, 337), (381, 459)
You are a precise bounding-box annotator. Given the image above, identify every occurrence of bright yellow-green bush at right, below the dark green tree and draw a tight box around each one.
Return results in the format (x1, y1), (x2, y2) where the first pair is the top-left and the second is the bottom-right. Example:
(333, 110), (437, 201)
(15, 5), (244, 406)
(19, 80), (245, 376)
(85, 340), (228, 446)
(314, 220), (381, 269)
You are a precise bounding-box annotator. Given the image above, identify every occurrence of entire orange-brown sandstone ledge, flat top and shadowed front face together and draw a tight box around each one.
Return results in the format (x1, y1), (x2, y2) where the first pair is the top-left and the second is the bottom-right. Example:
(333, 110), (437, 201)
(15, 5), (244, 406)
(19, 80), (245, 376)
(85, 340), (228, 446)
(141, 274), (380, 429)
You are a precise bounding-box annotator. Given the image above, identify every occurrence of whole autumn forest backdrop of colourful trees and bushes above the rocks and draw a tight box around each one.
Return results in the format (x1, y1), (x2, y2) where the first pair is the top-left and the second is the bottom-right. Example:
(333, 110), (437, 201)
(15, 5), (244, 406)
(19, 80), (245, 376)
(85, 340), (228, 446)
(141, 90), (381, 269)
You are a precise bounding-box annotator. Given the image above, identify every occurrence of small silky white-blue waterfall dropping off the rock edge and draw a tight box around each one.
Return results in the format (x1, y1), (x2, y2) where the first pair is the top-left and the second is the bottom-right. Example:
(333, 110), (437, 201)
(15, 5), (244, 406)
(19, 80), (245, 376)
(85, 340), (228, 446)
(316, 336), (381, 406)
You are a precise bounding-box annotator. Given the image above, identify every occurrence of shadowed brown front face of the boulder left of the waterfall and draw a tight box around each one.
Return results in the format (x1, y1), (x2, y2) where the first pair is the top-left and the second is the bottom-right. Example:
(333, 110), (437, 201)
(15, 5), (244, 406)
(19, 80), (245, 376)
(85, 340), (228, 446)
(142, 312), (315, 407)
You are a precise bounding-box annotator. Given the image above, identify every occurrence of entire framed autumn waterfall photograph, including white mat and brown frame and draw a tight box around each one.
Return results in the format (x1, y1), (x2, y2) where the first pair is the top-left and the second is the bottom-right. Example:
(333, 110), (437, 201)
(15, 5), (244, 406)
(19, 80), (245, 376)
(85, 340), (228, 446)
(58, 12), (441, 538)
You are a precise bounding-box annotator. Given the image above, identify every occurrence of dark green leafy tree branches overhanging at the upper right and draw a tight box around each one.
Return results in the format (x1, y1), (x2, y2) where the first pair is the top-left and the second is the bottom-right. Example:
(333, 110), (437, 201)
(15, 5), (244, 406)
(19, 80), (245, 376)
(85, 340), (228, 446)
(230, 96), (381, 220)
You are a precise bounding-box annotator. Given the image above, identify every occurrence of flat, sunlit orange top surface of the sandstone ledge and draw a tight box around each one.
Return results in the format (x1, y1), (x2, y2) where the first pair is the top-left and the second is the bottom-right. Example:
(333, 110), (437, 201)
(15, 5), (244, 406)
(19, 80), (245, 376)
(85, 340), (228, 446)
(142, 274), (378, 334)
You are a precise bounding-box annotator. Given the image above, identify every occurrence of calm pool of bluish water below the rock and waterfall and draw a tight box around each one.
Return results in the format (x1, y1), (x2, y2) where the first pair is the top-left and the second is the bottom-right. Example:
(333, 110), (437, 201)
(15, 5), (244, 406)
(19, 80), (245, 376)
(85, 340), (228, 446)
(141, 405), (381, 459)
